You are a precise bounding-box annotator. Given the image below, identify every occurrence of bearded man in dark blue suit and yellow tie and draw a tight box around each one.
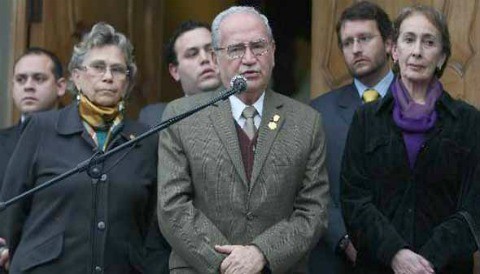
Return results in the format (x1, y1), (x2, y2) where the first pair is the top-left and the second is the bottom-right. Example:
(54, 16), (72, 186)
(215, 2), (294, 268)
(309, 1), (394, 273)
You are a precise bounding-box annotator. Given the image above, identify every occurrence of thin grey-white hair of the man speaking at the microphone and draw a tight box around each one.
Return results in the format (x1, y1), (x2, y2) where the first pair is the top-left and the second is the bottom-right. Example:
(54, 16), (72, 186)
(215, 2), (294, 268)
(212, 6), (273, 48)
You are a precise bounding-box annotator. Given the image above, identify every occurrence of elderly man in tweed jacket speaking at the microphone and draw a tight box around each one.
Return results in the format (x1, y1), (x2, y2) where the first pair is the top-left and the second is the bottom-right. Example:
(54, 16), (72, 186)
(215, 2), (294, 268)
(158, 7), (329, 273)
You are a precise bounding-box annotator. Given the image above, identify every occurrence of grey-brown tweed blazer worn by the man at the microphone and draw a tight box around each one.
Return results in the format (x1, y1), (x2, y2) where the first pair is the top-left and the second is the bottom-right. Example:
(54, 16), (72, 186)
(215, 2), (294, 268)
(158, 91), (329, 273)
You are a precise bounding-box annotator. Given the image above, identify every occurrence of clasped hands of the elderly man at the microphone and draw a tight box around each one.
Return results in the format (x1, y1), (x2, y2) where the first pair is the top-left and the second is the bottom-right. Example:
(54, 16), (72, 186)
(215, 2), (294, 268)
(215, 245), (267, 274)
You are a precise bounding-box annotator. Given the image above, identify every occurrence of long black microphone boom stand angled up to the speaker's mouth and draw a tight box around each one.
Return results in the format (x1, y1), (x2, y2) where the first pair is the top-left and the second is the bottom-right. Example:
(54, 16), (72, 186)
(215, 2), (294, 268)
(0, 83), (246, 212)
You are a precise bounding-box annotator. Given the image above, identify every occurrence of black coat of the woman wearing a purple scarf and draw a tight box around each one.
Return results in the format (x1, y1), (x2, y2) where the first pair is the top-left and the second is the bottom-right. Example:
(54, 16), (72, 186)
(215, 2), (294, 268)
(341, 92), (480, 274)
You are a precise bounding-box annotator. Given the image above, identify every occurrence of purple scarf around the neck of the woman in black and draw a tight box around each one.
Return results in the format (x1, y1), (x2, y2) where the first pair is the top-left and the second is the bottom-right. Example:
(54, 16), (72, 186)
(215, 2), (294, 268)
(392, 77), (443, 169)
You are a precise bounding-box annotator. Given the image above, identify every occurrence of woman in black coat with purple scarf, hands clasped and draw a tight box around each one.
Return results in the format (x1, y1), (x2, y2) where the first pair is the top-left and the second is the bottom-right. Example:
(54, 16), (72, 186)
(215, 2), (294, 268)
(341, 6), (480, 274)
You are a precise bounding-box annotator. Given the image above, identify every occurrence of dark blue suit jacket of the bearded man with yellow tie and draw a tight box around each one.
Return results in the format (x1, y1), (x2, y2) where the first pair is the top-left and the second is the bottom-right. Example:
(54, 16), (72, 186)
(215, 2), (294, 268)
(309, 83), (362, 274)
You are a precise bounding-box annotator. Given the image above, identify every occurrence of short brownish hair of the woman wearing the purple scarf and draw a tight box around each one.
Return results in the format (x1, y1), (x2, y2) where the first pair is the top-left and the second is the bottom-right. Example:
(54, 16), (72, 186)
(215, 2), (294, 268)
(393, 5), (452, 78)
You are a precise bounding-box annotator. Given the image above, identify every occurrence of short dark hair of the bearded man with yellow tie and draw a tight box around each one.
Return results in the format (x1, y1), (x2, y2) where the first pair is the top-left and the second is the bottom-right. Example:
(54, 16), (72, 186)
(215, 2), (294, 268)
(336, 1), (393, 49)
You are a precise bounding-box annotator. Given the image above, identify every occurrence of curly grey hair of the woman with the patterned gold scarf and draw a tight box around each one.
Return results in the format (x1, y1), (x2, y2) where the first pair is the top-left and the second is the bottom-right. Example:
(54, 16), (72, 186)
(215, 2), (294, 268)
(68, 22), (137, 95)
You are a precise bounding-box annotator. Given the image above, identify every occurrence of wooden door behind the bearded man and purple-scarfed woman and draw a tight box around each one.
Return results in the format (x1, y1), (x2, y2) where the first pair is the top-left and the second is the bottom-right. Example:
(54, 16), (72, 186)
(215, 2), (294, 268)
(311, 0), (480, 107)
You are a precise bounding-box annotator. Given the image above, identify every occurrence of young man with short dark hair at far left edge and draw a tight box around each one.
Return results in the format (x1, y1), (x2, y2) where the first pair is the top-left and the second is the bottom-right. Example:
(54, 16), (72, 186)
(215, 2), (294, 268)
(0, 48), (66, 272)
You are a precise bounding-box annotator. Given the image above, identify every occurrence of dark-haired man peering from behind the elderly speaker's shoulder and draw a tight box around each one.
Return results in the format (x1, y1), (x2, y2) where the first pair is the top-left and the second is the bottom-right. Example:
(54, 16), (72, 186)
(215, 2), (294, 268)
(138, 20), (220, 126)
